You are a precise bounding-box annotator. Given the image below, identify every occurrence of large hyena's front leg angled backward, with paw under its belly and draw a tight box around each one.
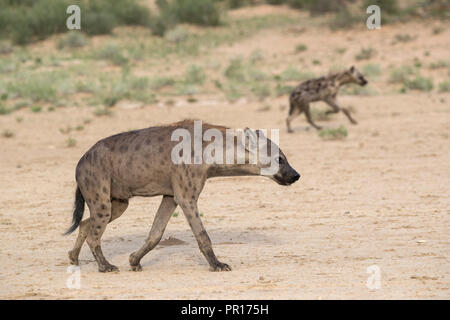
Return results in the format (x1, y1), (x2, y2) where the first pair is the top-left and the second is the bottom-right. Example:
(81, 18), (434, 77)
(129, 196), (177, 271)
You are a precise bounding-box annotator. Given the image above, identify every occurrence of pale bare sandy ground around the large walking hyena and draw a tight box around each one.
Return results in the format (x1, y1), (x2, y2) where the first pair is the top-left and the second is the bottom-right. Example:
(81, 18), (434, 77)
(0, 5), (450, 299)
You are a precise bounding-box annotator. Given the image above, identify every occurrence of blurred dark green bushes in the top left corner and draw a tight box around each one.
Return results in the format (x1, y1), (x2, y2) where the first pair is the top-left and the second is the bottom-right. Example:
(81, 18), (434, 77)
(0, 0), (150, 45)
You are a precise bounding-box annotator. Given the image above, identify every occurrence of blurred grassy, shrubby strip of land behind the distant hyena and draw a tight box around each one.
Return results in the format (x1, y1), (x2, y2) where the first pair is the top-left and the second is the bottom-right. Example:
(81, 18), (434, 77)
(0, 0), (450, 121)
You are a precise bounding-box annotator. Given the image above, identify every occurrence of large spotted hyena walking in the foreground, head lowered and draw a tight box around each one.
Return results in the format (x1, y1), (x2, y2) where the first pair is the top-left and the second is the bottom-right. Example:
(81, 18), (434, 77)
(67, 120), (300, 272)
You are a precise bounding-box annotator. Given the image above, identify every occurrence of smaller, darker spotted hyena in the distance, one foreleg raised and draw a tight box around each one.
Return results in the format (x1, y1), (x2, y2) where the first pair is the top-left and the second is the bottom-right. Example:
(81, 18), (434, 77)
(286, 66), (367, 132)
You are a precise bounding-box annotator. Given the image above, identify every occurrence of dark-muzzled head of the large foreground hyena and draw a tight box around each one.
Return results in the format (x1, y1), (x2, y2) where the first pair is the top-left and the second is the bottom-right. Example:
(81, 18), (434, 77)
(245, 129), (300, 186)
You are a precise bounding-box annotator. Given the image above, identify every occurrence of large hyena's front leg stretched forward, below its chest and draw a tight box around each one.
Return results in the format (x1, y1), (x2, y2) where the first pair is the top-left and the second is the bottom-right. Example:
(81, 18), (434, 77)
(178, 199), (231, 271)
